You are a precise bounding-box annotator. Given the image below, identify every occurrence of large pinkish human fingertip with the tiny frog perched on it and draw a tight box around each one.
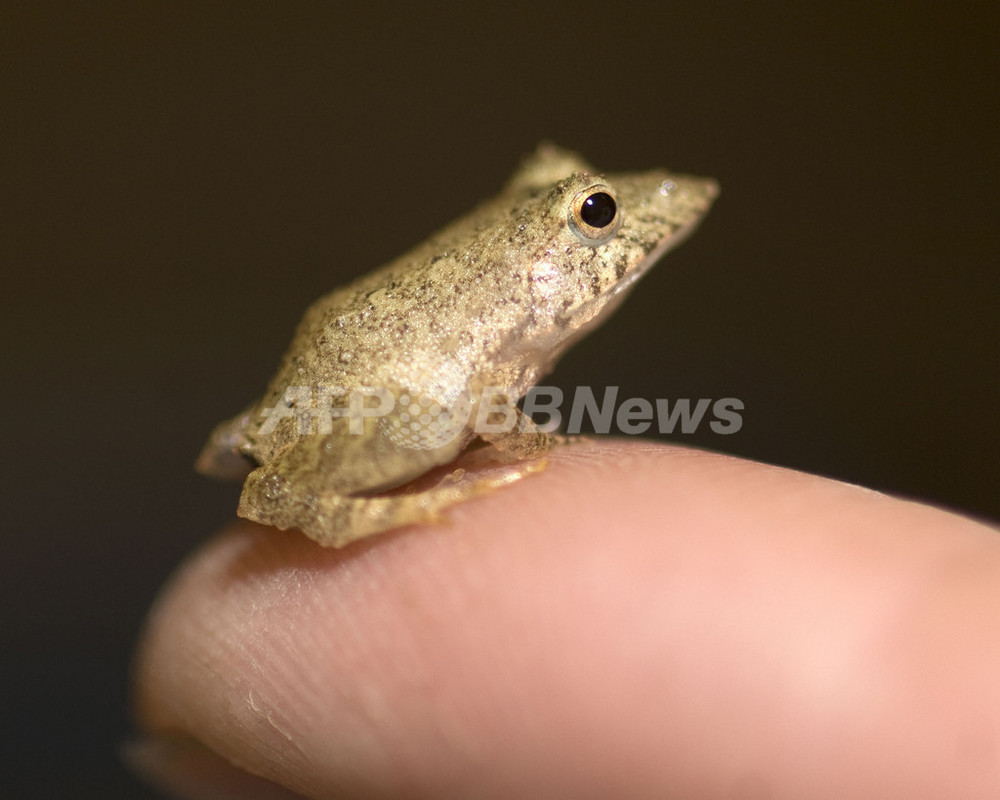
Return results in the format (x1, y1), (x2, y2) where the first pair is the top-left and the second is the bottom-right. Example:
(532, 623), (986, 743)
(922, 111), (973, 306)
(131, 440), (1000, 798)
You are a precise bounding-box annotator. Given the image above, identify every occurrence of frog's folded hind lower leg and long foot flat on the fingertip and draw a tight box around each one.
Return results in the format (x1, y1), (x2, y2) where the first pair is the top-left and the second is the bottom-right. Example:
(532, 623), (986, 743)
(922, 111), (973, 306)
(237, 461), (544, 547)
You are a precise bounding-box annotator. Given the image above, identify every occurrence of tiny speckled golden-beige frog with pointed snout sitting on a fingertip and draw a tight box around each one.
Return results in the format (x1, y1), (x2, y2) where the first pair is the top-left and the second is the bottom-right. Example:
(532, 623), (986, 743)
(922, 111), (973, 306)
(197, 144), (718, 547)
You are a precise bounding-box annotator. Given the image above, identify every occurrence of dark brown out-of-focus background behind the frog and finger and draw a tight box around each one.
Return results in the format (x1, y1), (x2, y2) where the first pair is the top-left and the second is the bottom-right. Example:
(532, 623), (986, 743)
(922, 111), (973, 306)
(0, 0), (1000, 798)
